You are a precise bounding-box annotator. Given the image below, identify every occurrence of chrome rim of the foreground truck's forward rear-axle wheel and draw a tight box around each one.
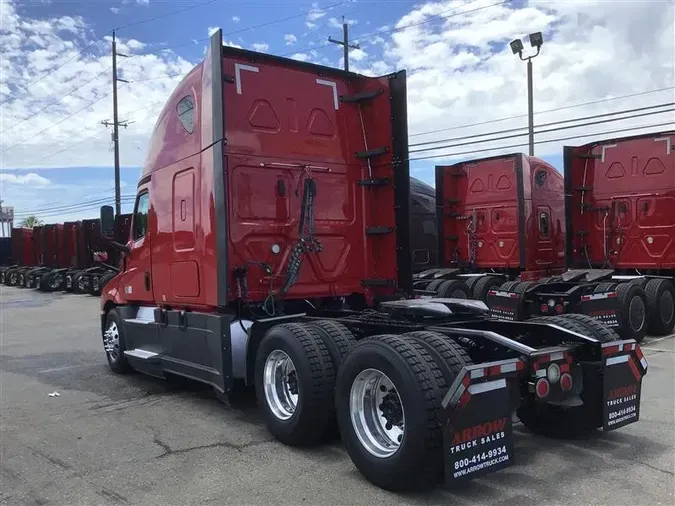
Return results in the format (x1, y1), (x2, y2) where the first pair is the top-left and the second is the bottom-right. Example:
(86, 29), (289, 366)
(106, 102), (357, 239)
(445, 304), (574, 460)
(263, 350), (300, 420)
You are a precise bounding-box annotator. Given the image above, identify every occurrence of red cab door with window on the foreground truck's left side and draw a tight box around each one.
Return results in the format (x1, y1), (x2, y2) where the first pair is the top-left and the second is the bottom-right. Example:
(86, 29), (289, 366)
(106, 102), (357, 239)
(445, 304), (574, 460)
(121, 188), (154, 303)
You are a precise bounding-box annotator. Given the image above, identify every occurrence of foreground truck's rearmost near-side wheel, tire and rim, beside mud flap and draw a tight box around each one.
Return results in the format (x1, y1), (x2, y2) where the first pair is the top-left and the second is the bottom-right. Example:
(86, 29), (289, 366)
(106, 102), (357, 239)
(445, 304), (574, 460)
(335, 335), (448, 491)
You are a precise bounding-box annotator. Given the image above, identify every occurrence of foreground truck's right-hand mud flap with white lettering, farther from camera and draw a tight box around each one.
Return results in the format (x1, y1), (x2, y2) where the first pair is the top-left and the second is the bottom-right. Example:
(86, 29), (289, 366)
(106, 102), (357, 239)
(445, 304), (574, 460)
(602, 339), (647, 431)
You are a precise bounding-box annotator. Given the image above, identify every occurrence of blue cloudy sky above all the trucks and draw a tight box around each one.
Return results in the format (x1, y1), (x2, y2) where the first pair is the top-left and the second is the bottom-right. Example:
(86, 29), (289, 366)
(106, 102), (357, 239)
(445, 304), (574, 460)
(0, 0), (675, 222)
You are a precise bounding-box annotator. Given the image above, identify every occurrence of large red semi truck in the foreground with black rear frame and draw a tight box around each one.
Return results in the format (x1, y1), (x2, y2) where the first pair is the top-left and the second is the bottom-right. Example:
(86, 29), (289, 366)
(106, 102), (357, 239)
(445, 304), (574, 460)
(95, 30), (647, 490)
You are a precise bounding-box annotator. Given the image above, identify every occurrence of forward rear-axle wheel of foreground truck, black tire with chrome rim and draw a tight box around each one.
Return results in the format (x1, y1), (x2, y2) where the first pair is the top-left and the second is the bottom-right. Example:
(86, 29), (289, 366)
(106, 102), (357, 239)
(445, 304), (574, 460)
(254, 323), (335, 446)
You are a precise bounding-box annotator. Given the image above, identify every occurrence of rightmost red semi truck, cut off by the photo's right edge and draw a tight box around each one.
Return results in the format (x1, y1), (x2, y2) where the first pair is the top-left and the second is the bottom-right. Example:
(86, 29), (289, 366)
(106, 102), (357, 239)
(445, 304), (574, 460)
(488, 131), (675, 342)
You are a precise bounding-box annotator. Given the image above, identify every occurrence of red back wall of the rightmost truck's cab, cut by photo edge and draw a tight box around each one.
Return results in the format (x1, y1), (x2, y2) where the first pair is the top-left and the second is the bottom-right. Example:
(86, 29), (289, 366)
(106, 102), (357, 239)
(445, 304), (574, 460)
(565, 131), (675, 270)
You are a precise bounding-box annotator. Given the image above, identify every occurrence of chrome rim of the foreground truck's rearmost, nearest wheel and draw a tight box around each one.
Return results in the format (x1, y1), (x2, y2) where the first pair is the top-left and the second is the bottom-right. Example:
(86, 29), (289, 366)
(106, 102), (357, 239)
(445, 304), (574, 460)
(349, 369), (405, 458)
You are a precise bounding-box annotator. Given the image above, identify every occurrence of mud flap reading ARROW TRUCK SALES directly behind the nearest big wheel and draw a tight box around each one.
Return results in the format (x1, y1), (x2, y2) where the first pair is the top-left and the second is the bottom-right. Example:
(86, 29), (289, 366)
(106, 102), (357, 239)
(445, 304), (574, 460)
(443, 359), (525, 485)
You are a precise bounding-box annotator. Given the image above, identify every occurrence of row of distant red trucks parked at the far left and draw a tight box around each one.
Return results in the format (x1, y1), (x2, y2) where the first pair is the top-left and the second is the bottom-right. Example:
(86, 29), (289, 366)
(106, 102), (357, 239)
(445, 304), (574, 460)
(0, 214), (131, 296)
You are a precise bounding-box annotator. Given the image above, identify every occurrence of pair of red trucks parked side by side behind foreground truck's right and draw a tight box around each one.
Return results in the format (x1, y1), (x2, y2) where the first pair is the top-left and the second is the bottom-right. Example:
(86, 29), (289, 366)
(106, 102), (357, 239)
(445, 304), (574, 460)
(415, 131), (675, 342)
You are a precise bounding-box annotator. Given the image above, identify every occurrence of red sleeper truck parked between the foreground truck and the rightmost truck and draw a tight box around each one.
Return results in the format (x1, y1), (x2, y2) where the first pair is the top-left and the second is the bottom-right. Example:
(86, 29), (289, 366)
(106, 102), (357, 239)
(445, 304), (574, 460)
(415, 153), (566, 301)
